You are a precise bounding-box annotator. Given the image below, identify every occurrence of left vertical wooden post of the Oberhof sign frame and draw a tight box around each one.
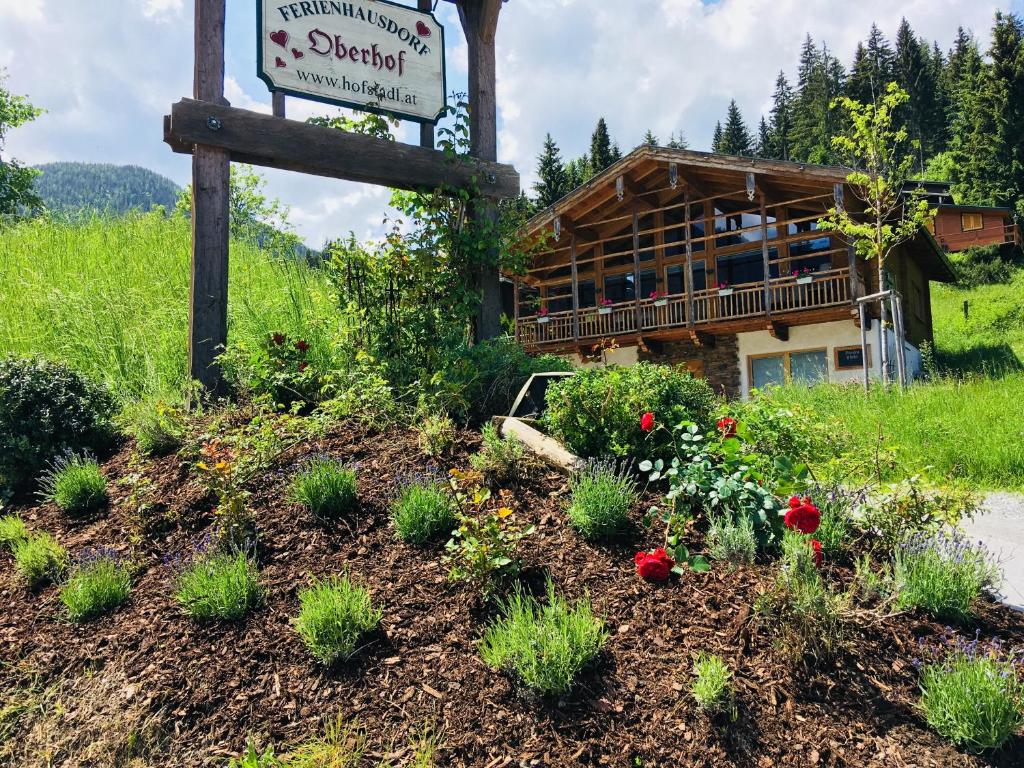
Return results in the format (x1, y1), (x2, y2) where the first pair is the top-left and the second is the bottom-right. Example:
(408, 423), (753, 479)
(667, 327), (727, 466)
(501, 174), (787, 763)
(188, 0), (230, 395)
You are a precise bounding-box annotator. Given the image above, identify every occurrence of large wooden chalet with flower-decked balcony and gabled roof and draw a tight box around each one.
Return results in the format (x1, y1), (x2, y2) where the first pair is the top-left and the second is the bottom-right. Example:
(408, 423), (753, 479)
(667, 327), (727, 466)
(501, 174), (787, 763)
(510, 146), (954, 396)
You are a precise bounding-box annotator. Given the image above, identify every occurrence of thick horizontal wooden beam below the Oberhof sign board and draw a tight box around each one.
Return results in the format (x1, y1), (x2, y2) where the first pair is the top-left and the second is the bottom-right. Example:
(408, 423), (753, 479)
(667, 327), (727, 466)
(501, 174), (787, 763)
(164, 98), (519, 199)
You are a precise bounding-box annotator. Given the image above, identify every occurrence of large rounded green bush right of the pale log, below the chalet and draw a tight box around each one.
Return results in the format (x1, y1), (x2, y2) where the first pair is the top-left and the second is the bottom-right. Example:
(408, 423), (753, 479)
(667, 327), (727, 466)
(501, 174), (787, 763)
(541, 362), (716, 457)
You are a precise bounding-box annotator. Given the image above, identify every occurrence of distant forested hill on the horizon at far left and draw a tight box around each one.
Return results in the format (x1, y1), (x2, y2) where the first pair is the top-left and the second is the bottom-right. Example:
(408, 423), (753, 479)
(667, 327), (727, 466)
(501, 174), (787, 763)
(36, 163), (179, 214)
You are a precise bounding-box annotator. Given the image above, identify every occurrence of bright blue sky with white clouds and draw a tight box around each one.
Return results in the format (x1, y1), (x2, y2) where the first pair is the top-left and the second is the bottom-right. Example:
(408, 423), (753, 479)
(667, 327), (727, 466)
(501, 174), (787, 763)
(0, 0), (1024, 248)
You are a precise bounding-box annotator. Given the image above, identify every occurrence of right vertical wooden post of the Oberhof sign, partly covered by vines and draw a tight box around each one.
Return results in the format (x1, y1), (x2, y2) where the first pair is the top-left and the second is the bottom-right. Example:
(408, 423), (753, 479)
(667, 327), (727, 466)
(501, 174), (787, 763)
(458, 0), (502, 341)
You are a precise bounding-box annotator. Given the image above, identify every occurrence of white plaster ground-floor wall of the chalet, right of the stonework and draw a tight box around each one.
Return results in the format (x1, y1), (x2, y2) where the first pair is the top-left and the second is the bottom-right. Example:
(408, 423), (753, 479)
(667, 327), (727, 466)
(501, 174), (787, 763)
(737, 319), (888, 397)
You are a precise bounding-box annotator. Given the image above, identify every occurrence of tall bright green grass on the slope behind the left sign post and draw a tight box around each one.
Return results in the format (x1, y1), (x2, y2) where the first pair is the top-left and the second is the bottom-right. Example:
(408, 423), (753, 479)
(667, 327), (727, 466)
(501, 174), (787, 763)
(0, 213), (338, 399)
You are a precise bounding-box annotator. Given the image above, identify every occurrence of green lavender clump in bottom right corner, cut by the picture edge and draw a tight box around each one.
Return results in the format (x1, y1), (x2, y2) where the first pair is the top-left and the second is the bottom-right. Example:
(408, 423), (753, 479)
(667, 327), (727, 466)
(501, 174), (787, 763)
(921, 644), (1024, 752)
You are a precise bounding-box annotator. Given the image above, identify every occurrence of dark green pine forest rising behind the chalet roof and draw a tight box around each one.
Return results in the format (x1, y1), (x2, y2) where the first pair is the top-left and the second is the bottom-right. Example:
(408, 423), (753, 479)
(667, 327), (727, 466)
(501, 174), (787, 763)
(532, 12), (1024, 221)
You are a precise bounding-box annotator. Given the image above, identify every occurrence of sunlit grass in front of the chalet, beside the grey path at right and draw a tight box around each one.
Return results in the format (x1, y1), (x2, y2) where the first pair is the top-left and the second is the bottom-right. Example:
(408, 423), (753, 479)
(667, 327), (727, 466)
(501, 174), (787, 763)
(770, 373), (1024, 489)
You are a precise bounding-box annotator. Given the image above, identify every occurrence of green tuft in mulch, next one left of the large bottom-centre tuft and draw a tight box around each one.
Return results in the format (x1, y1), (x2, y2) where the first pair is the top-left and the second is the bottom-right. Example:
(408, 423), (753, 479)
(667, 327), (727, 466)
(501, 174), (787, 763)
(295, 577), (383, 666)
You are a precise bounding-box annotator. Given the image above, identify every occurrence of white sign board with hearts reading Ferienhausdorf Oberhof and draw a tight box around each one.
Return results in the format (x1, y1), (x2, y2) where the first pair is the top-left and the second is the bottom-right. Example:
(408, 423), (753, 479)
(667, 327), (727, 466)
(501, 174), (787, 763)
(256, 0), (445, 123)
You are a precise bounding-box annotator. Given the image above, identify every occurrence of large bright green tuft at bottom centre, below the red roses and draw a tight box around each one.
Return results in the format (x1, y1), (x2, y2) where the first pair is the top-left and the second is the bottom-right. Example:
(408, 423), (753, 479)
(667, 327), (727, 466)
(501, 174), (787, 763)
(480, 581), (607, 694)
